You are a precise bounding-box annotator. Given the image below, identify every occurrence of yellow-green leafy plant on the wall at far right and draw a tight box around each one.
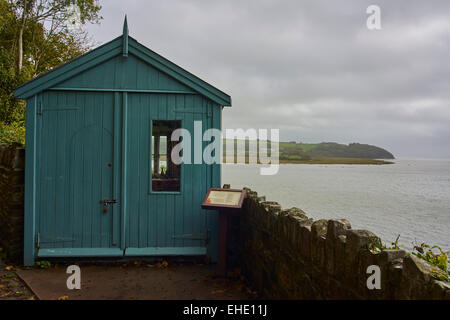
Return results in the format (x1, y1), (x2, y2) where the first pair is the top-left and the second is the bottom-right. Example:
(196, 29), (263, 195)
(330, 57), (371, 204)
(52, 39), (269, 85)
(412, 243), (450, 281)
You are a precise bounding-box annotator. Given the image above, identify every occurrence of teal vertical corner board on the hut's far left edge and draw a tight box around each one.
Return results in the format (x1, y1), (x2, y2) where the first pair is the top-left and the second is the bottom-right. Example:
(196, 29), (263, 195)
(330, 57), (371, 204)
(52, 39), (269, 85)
(24, 95), (38, 266)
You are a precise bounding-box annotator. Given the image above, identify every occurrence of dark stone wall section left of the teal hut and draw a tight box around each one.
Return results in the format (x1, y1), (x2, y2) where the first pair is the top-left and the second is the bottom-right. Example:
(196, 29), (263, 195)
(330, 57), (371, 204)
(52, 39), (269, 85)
(0, 144), (25, 263)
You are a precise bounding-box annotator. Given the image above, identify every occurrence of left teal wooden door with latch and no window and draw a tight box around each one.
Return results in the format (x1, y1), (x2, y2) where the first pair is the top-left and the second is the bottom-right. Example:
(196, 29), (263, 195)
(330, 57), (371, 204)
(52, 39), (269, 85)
(37, 92), (122, 257)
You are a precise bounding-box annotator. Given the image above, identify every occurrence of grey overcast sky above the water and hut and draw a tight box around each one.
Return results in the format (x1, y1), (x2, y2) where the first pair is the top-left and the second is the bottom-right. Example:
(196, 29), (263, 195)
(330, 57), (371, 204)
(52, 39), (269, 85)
(88, 0), (450, 158)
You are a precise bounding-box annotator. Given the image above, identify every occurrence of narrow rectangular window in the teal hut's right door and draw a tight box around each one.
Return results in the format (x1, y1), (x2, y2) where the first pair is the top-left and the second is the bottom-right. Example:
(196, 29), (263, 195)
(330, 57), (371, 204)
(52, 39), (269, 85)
(151, 120), (181, 192)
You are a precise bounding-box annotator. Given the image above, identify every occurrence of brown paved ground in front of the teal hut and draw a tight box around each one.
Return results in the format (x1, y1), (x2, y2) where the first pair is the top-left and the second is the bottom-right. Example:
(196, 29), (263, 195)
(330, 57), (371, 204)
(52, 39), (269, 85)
(0, 261), (257, 300)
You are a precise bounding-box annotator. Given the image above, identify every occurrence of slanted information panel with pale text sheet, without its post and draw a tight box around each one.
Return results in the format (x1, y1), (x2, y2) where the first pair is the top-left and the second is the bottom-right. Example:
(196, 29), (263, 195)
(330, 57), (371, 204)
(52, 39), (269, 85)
(202, 188), (245, 210)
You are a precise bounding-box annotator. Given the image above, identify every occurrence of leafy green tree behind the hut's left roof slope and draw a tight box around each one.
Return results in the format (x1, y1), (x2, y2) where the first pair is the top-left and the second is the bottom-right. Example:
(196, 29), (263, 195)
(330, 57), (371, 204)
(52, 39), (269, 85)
(0, 0), (101, 142)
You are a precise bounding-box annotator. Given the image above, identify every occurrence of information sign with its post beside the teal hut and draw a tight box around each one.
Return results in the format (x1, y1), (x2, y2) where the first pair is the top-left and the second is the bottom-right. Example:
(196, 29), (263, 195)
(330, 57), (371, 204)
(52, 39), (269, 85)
(202, 188), (245, 277)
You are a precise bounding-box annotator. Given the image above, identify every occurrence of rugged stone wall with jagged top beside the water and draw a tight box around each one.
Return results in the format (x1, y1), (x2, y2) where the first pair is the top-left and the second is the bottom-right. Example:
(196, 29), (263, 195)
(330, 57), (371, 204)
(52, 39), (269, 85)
(228, 189), (450, 300)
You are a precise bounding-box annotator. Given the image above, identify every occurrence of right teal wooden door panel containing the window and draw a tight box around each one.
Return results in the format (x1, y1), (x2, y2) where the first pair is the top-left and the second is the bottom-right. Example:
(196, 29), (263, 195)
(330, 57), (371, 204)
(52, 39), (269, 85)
(122, 93), (212, 256)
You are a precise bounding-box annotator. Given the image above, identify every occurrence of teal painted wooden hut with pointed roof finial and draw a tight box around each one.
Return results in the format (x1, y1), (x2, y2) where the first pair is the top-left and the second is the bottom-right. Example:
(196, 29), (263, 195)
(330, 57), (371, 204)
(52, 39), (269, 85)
(15, 18), (231, 265)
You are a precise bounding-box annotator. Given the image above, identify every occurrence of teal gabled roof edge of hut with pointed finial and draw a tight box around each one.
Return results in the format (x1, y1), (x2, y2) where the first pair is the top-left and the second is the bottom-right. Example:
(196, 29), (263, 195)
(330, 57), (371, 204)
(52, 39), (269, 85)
(14, 17), (231, 106)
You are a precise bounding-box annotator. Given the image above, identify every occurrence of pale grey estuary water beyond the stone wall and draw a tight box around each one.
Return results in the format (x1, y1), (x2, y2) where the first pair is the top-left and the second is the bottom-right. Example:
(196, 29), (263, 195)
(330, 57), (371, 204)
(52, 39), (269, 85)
(222, 159), (450, 251)
